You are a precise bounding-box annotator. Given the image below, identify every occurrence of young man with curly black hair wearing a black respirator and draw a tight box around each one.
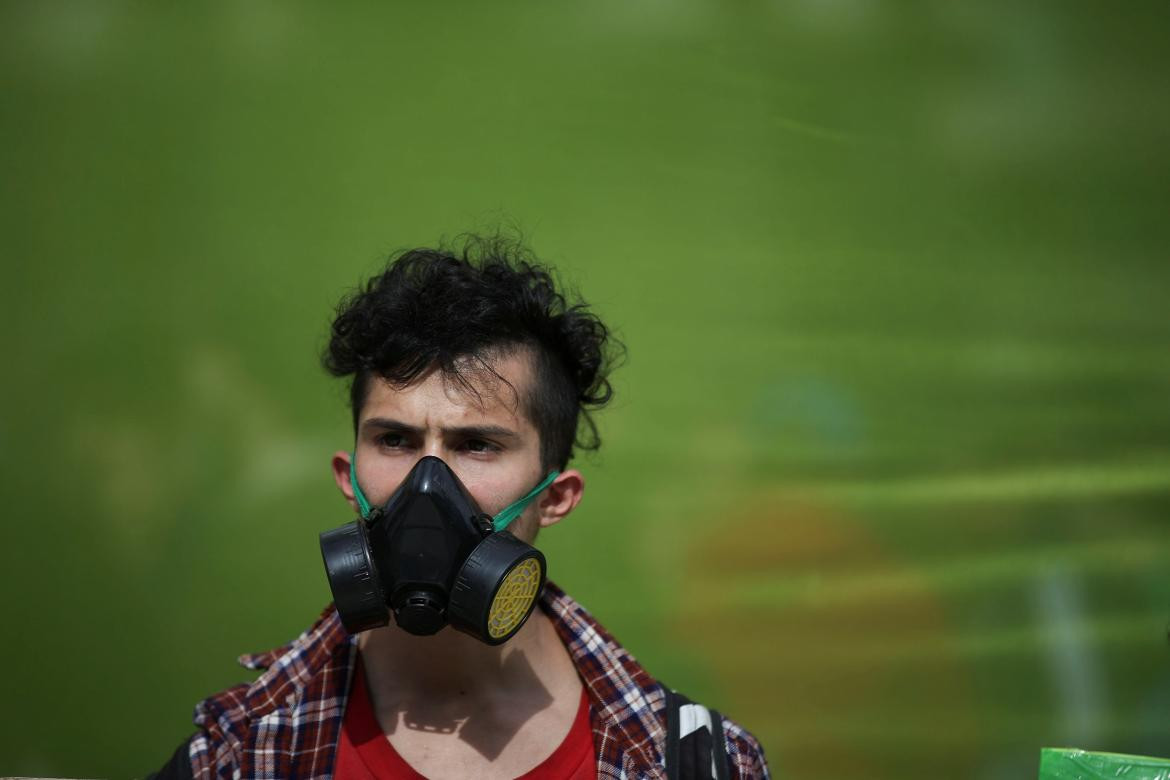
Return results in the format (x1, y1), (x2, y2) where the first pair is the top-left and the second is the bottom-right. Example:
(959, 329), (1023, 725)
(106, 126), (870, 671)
(150, 240), (768, 779)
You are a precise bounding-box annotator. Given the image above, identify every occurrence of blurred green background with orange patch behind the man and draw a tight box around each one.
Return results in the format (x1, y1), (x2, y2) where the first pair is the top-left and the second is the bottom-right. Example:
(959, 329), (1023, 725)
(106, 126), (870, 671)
(0, 0), (1170, 779)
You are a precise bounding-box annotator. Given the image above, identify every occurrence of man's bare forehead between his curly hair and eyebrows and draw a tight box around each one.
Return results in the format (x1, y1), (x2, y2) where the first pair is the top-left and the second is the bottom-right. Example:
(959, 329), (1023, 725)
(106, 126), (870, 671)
(360, 351), (532, 428)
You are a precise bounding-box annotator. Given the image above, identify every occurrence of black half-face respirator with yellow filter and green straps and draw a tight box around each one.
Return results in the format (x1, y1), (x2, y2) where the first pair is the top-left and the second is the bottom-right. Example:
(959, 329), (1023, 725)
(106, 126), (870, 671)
(321, 456), (559, 644)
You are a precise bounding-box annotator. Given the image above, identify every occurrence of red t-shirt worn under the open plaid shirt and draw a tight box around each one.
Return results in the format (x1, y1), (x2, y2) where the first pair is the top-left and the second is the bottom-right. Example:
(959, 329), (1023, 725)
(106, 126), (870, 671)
(333, 655), (597, 780)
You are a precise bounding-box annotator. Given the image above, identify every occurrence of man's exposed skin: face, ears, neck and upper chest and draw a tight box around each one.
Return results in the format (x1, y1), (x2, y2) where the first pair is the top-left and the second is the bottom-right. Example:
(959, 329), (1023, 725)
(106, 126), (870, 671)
(331, 352), (585, 779)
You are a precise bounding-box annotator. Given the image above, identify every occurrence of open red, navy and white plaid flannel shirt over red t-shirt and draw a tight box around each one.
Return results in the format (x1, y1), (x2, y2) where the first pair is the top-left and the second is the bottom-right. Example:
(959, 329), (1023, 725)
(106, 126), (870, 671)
(190, 582), (769, 780)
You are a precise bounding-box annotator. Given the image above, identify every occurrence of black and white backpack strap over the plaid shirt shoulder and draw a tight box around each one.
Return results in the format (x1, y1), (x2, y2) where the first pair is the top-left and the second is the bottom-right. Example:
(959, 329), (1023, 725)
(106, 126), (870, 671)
(663, 686), (730, 780)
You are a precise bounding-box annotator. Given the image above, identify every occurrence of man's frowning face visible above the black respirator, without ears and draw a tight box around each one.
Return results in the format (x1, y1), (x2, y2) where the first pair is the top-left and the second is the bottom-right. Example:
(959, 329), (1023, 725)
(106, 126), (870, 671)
(355, 354), (543, 540)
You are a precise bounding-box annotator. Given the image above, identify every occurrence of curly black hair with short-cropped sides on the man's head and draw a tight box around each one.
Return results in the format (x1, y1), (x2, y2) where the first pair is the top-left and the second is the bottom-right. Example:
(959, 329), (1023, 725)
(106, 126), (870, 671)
(322, 236), (624, 469)
